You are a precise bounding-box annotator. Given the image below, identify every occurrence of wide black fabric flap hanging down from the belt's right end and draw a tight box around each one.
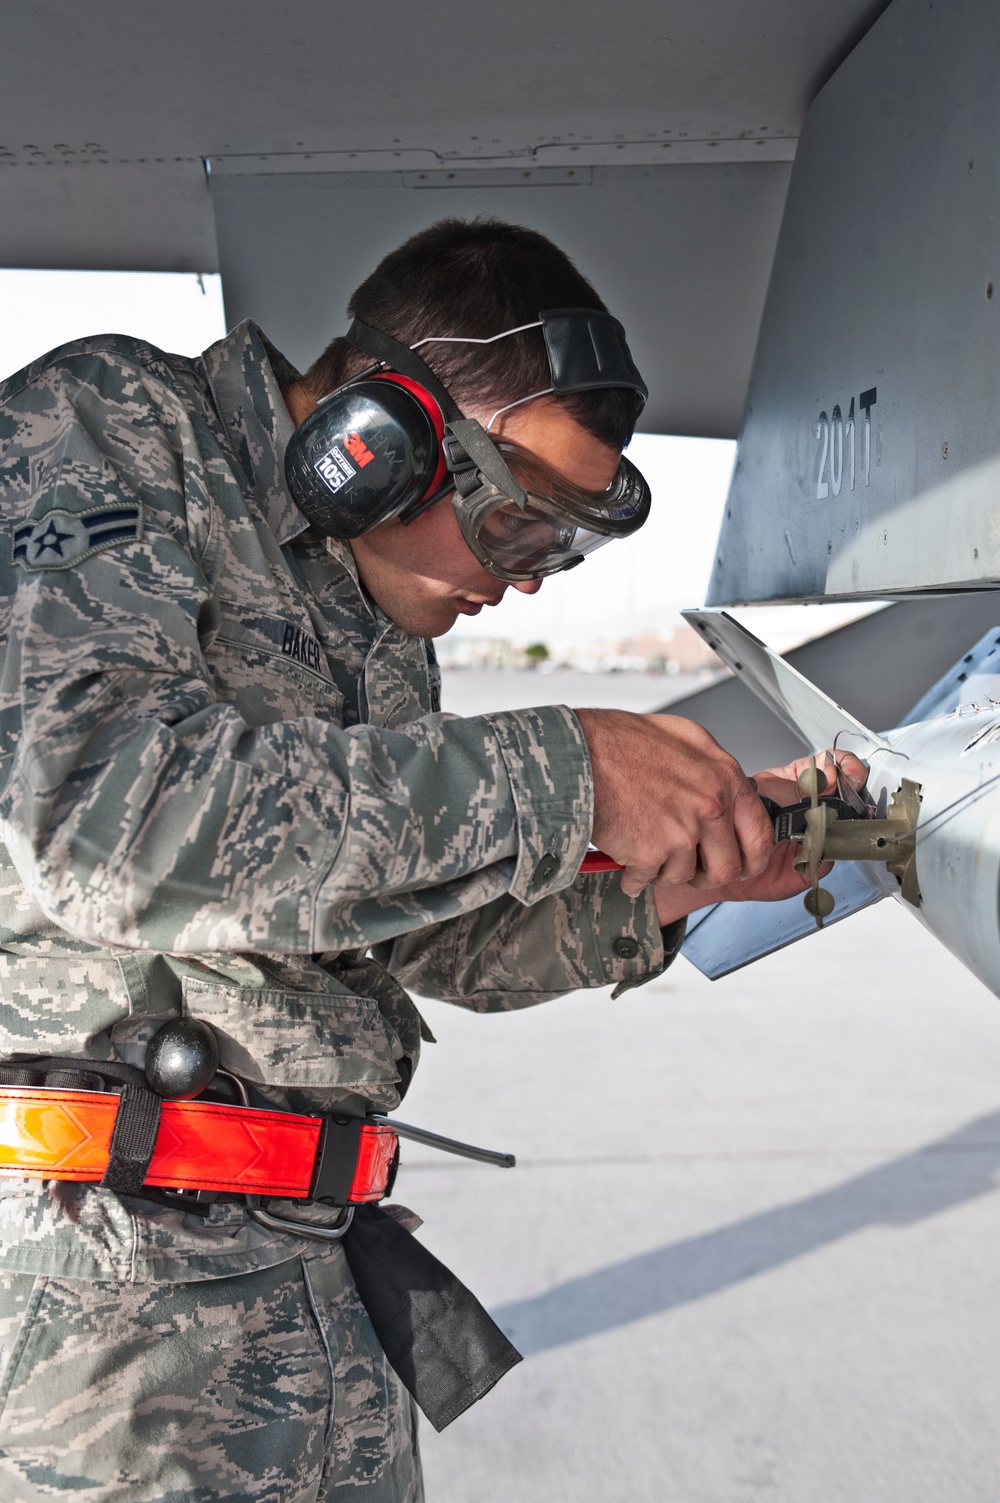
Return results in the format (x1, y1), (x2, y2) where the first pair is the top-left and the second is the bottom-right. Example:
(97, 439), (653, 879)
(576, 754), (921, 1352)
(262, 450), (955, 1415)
(343, 1205), (522, 1431)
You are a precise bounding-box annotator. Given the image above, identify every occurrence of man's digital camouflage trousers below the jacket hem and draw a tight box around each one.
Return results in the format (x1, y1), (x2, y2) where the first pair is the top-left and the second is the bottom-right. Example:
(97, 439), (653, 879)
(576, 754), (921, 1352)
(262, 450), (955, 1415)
(0, 1246), (424, 1503)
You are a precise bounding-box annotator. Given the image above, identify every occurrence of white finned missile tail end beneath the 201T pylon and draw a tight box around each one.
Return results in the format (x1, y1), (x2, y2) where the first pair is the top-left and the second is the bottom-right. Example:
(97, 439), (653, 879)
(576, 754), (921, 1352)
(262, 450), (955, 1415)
(683, 610), (1000, 995)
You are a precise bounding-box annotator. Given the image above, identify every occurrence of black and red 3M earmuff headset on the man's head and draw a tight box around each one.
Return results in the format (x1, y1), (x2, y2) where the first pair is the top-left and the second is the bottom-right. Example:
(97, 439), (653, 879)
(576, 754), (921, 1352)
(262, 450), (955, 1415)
(284, 308), (647, 540)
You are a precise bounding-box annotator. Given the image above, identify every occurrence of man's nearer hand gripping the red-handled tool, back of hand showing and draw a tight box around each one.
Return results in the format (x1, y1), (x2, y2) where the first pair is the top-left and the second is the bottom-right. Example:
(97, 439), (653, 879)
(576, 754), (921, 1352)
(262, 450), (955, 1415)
(574, 709), (774, 897)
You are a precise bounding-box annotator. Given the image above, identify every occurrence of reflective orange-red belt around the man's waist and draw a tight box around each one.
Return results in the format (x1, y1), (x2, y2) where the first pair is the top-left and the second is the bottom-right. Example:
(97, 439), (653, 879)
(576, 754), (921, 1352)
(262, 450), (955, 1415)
(0, 1085), (398, 1205)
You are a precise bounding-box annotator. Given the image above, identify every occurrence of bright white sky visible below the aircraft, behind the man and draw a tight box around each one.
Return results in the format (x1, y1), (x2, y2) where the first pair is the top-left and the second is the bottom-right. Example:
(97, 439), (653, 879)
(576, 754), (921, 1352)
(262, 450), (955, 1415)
(0, 269), (871, 649)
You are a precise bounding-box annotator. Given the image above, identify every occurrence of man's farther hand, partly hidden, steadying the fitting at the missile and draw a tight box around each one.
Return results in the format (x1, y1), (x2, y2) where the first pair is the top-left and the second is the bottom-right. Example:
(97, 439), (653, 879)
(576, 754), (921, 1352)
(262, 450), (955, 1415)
(656, 752), (868, 927)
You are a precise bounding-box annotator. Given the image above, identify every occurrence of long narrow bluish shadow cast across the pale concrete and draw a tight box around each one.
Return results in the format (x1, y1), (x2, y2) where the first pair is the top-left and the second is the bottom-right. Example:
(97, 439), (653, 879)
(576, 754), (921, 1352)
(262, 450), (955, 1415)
(492, 1112), (1000, 1357)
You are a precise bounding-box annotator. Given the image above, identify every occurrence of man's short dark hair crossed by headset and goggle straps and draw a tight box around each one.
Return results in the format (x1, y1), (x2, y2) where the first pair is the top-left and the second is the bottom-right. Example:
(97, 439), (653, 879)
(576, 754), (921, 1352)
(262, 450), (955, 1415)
(305, 218), (641, 449)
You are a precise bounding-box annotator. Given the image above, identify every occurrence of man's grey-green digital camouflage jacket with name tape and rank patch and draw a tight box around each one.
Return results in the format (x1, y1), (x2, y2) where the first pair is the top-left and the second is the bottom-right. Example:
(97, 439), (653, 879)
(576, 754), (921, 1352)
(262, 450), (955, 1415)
(0, 323), (674, 1279)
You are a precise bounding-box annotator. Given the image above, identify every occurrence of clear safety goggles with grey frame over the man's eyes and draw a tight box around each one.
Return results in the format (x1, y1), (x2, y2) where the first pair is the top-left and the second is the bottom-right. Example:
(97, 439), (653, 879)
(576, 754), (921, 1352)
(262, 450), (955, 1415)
(453, 439), (650, 583)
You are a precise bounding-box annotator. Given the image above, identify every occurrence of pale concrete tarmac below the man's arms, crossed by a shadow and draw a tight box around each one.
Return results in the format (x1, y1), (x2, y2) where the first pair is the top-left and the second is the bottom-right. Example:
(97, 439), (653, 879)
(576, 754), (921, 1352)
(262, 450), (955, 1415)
(395, 902), (1000, 1503)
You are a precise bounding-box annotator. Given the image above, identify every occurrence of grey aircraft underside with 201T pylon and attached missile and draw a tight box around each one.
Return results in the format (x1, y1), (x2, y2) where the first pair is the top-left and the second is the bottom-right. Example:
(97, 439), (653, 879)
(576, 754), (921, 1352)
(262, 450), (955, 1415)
(0, 0), (1000, 990)
